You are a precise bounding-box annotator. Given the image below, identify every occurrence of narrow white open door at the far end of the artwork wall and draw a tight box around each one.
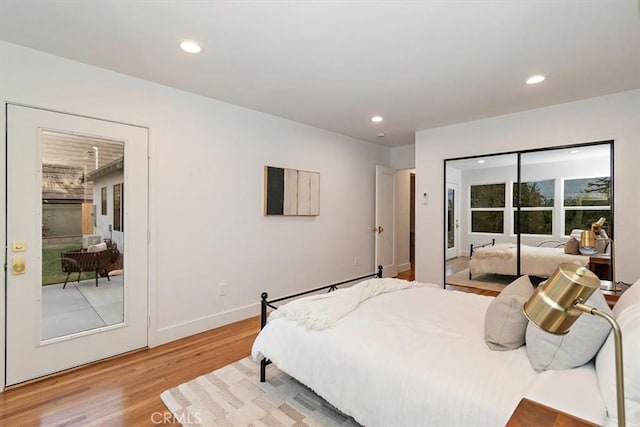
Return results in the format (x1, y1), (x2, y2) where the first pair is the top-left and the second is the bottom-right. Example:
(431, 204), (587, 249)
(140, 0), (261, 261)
(375, 166), (398, 277)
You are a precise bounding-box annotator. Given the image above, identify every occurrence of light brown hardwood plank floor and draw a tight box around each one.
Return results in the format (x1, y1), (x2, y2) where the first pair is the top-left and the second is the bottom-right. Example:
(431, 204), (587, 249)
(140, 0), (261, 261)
(0, 270), (497, 427)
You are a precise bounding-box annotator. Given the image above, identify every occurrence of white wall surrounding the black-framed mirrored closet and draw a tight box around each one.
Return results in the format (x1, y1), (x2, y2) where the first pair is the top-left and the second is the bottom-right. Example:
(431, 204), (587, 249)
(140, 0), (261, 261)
(416, 90), (640, 283)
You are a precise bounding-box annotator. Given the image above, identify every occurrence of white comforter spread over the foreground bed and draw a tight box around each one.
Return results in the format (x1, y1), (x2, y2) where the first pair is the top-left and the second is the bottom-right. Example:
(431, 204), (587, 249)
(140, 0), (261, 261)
(252, 285), (606, 427)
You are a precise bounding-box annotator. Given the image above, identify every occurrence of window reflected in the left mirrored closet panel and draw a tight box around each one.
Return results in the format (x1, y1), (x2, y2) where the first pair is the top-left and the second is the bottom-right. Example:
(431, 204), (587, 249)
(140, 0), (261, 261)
(471, 183), (506, 234)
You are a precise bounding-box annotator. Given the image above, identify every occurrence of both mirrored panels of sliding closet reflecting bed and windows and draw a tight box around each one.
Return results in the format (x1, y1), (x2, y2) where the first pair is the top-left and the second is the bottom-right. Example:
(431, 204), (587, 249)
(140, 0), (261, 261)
(445, 142), (614, 291)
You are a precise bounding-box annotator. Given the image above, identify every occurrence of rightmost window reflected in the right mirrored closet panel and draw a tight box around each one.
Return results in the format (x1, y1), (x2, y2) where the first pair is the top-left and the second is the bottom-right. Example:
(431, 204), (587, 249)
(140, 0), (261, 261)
(564, 176), (611, 235)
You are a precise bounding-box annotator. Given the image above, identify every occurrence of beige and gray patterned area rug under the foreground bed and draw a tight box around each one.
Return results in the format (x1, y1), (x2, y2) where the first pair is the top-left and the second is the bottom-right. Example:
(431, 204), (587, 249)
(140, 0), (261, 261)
(160, 357), (359, 427)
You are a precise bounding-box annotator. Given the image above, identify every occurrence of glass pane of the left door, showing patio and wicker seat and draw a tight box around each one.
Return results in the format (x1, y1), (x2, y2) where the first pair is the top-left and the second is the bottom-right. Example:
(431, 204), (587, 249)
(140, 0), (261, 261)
(40, 130), (125, 340)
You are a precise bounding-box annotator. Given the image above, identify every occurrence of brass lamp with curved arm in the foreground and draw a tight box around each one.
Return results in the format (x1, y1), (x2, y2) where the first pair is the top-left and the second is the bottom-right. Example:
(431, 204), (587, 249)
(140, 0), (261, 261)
(523, 263), (625, 426)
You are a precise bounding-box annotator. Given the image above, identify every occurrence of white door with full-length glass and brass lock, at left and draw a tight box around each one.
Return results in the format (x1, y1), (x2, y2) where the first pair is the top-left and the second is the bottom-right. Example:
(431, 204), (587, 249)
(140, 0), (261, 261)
(6, 105), (148, 385)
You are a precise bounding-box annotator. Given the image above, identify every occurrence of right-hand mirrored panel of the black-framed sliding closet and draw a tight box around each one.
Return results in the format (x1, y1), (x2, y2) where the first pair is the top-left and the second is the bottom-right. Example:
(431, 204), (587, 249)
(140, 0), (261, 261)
(514, 143), (613, 284)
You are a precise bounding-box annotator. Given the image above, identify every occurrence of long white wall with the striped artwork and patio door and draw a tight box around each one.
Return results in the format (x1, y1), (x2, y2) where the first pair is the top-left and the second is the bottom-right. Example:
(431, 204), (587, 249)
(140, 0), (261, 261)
(0, 42), (390, 378)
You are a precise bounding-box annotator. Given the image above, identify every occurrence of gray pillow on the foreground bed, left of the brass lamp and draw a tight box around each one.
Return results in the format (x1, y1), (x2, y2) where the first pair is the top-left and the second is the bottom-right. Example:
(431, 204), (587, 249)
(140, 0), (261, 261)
(484, 276), (533, 351)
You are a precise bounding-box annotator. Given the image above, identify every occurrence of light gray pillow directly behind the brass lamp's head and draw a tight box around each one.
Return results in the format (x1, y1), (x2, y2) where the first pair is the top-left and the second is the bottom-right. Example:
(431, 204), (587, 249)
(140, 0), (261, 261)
(526, 289), (611, 371)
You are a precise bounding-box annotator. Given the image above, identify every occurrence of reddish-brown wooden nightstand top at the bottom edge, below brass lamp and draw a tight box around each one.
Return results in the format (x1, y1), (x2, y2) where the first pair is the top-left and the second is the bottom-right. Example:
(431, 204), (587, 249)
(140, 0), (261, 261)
(507, 398), (597, 427)
